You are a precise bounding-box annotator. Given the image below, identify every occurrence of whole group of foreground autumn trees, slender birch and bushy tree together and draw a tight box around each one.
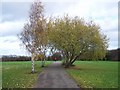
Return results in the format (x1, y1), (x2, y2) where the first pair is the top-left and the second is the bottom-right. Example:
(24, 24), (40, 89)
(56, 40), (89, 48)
(19, 1), (108, 72)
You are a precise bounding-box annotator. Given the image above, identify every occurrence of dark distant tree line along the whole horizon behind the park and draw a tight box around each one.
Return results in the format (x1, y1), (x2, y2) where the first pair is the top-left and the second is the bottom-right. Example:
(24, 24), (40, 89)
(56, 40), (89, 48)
(2, 48), (120, 61)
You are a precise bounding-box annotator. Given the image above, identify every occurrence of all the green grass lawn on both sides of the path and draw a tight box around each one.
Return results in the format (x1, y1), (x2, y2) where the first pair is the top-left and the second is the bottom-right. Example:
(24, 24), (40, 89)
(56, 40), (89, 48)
(0, 61), (120, 88)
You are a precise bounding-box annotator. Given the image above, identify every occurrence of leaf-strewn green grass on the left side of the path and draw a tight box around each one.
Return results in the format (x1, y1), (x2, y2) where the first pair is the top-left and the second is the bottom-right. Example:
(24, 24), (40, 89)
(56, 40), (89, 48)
(2, 61), (52, 88)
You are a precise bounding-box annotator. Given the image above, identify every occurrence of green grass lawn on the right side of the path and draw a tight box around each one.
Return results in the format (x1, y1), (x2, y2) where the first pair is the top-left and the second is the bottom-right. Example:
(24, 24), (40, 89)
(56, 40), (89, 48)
(66, 61), (120, 88)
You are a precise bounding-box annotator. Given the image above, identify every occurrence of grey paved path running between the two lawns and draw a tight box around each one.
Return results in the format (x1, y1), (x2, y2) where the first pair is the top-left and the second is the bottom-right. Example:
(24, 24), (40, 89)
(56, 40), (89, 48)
(33, 61), (79, 88)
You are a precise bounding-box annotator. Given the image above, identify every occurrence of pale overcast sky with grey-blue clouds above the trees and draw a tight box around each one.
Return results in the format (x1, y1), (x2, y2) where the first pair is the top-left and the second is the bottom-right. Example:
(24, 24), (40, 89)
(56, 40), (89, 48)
(0, 0), (118, 55)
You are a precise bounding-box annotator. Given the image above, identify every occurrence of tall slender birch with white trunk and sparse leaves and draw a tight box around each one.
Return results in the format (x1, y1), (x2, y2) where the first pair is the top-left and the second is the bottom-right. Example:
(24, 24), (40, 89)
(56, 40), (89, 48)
(19, 1), (45, 73)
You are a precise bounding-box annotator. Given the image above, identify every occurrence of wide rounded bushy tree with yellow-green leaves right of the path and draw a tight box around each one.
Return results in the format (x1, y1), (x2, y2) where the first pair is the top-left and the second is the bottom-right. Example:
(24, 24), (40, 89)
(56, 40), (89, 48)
(48, 16), (108, 67)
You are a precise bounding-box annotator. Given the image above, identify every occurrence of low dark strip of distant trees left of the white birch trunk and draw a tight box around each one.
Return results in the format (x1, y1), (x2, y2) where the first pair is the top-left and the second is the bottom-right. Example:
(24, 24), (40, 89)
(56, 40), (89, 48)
(2, 56), (31, 62)
